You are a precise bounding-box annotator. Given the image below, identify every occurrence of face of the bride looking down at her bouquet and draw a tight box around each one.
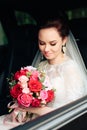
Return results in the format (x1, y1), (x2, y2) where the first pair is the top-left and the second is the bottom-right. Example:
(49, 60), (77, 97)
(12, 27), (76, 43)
(38, 27), (65, 60)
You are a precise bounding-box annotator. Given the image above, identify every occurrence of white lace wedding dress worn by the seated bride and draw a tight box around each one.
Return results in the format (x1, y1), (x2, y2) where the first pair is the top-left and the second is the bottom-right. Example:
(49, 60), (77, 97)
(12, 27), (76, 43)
(39, 58), (87, 109)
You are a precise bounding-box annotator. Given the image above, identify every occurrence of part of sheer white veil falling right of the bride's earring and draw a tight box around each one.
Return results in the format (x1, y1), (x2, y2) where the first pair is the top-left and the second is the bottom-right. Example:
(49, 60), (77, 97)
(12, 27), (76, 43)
(66, 32), (87, 75)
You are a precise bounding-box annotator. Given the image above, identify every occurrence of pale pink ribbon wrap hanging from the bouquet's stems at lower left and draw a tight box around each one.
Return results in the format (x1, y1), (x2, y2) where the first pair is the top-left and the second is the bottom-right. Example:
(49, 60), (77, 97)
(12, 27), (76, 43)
(4, 101), (31, 125)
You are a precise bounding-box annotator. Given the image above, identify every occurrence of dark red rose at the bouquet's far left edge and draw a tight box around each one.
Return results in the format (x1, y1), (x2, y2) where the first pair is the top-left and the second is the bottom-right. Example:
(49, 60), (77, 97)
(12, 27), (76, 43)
(10, 84), (22, 98)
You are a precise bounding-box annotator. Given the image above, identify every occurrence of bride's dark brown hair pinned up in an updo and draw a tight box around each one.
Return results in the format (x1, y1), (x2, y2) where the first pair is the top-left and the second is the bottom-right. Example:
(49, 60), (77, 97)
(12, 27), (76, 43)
(39, 13), (69, 38)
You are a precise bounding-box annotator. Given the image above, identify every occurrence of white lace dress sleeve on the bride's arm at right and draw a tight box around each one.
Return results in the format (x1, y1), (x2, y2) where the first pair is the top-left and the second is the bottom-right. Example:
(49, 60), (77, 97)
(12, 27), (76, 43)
(63, 62), (86, 100)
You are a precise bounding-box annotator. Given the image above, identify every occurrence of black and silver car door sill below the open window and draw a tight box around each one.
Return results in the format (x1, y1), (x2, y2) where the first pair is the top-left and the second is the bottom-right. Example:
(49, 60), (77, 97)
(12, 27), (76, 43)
(12, 96), (87, 130)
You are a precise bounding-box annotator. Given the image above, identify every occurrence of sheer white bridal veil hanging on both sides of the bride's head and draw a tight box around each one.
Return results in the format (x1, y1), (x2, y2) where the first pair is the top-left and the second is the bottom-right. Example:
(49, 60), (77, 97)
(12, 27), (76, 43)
(32, 31), (87, 93)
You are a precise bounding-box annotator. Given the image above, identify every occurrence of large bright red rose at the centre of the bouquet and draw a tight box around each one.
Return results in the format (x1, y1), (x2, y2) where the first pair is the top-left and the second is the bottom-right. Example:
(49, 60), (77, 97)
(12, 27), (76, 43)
(28, 80), (42, 92)
